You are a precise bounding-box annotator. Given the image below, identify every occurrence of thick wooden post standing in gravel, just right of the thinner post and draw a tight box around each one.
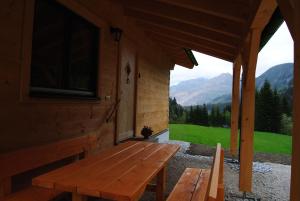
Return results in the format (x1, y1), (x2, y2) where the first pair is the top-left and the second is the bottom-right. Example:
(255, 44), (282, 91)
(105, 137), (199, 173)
(239, 29), (261, 192)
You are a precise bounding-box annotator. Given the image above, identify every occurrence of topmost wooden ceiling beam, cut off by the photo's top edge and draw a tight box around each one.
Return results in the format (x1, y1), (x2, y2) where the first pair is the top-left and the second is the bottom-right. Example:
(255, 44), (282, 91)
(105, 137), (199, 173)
(157, 0), (249, 23)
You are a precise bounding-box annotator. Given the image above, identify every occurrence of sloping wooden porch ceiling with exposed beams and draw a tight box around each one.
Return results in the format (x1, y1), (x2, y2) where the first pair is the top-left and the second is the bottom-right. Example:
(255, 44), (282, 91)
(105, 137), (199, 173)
(120, 0), (260, 68)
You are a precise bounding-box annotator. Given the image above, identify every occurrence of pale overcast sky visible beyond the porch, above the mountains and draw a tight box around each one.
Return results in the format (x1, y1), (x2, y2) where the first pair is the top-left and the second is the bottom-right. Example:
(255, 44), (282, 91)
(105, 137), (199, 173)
(170, 23), (294, 85)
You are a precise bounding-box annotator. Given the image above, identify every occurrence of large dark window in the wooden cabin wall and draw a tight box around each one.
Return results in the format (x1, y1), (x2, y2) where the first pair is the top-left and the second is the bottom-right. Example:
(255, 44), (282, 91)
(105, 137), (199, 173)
(30, 0), (99, 97)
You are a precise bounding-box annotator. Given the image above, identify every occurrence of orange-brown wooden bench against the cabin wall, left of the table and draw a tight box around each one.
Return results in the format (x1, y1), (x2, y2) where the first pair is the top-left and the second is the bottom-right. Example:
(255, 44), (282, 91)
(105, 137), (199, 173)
(0, 135), (97, 201)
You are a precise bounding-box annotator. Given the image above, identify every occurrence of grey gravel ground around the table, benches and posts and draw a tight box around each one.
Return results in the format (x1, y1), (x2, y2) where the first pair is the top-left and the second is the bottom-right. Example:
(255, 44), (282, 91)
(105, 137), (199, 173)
(141, 141), (291, 201)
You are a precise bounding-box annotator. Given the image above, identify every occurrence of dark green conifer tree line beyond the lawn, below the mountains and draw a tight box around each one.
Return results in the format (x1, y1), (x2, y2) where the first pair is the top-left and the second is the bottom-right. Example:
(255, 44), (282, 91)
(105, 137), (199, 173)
(169, 81), (292, 135)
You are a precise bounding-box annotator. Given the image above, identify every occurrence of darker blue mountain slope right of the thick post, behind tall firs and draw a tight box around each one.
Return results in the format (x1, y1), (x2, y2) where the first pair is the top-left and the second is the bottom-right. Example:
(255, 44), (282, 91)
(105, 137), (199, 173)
(256, 63), (293, 91)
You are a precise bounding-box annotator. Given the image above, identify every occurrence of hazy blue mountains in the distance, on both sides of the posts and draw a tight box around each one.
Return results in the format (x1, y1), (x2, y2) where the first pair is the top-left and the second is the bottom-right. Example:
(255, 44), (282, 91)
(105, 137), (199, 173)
(170, 63), (293, 106)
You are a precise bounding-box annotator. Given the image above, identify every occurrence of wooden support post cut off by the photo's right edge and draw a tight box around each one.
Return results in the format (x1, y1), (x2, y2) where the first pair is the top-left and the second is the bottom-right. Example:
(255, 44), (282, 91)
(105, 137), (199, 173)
(290, 0), (300, 201)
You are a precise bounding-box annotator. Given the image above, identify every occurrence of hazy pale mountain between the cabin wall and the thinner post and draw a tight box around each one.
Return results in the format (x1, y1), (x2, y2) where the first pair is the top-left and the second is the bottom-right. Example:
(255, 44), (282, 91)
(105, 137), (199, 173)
(170, 73), (232, 106)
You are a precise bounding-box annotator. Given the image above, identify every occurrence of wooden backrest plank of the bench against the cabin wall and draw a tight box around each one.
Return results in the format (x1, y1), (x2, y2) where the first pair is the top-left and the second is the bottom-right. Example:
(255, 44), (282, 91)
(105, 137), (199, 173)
(0, 135), (97, 178)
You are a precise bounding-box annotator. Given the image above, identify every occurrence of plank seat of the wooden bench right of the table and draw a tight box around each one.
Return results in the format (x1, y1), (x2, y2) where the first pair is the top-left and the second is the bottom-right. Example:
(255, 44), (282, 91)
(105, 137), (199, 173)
(167, 168), (210, 201)
